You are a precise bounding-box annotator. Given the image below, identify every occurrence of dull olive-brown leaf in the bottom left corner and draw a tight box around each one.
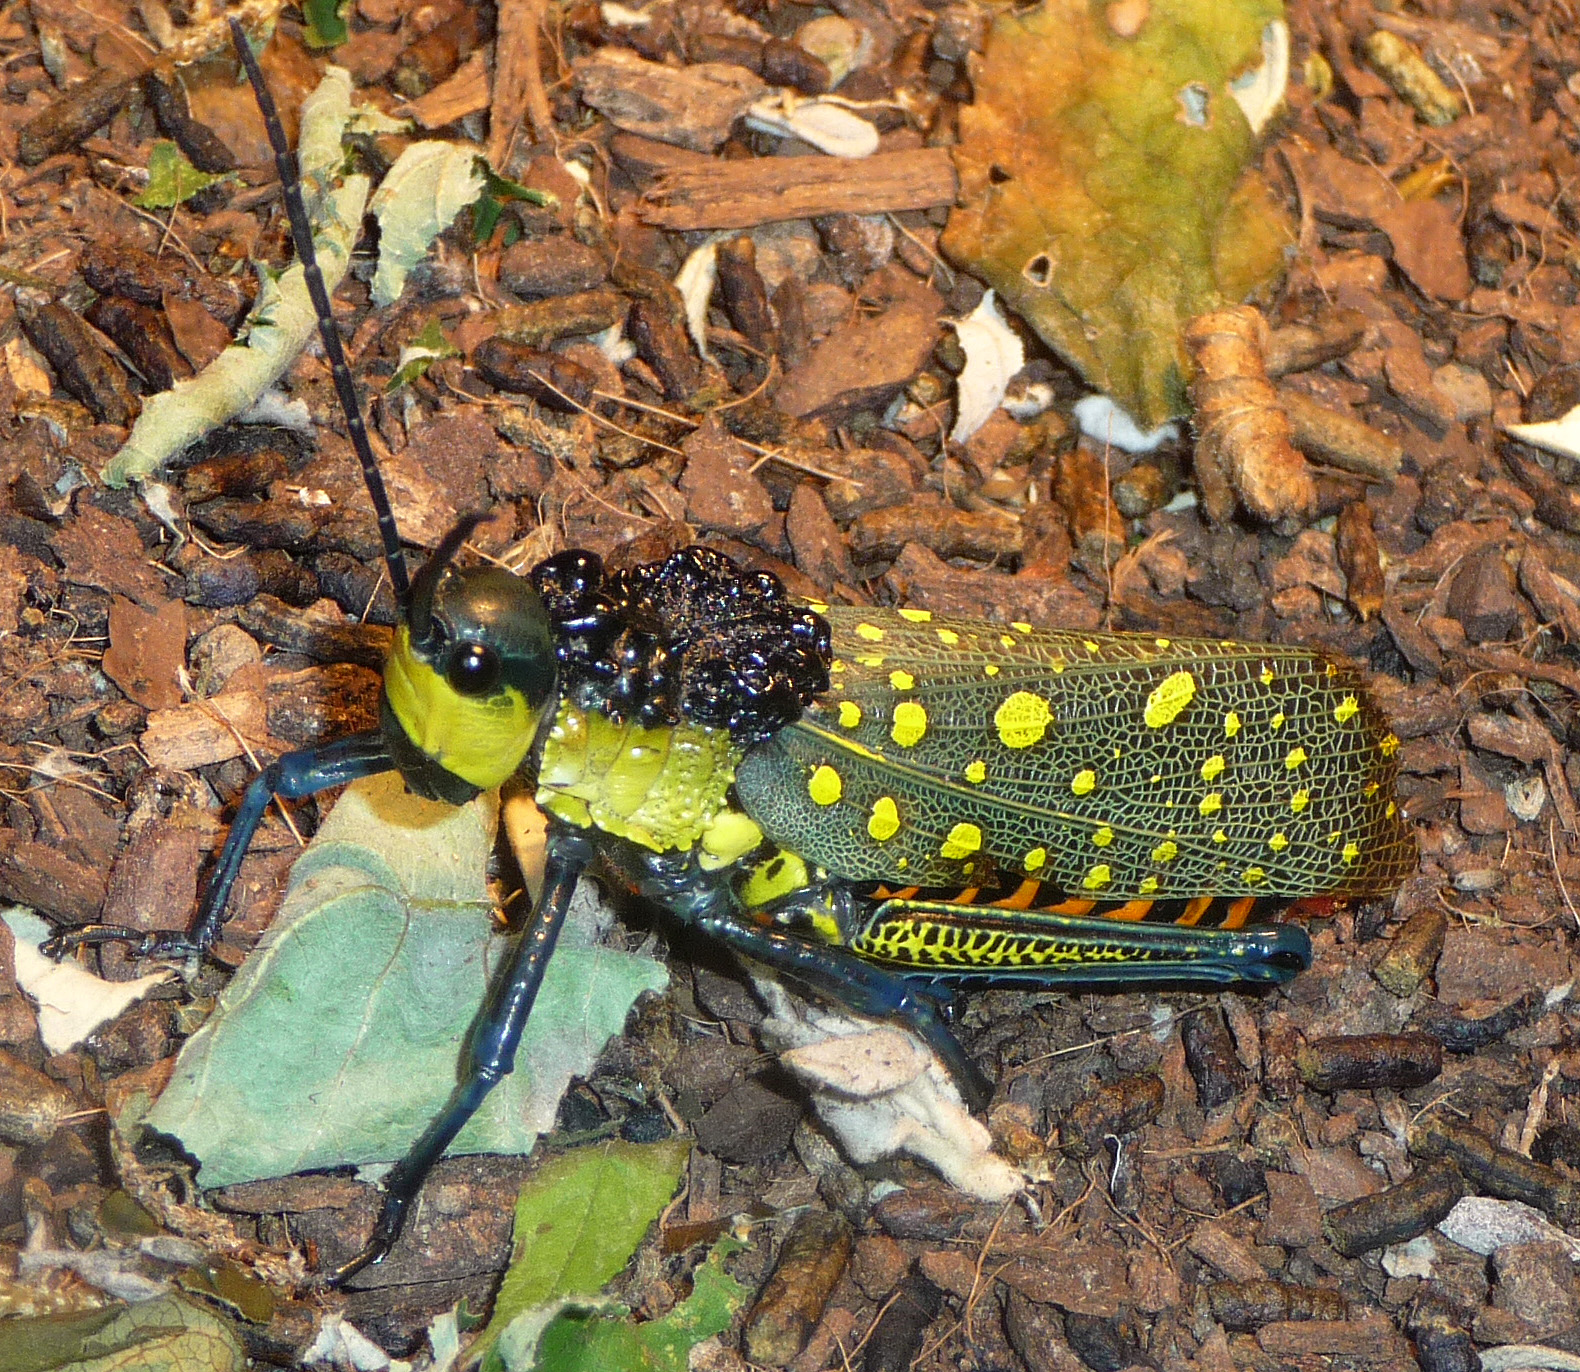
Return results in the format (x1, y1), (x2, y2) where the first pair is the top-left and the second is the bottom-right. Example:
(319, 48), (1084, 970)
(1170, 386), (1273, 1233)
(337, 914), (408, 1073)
(0, 1296), (246, 1372)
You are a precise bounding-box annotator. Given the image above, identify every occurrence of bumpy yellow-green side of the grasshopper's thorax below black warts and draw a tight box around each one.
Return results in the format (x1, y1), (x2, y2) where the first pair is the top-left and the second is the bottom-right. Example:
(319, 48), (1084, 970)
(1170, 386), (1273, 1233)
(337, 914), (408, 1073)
(537, 702), (763, 868)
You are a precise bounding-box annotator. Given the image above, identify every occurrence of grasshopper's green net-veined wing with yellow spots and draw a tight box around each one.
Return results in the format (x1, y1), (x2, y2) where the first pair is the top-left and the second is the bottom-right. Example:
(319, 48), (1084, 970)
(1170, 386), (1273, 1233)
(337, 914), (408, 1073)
(736, 609), (1414, 901)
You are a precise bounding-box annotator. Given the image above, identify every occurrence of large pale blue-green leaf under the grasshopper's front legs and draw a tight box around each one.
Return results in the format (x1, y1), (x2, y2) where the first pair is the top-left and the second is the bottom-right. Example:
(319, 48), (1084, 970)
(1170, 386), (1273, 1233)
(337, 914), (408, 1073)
(145, 773), (665, 1185)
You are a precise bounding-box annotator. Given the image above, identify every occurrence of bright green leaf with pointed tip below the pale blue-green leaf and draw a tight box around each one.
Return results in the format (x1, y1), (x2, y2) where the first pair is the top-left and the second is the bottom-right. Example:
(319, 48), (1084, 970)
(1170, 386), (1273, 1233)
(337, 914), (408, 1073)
(472, 1140), (690, 1356)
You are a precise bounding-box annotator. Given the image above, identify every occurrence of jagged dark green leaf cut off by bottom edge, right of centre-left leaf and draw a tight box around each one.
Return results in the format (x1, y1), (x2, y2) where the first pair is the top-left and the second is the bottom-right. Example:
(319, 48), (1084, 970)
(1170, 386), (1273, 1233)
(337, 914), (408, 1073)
(507, 1244), (751, 1372)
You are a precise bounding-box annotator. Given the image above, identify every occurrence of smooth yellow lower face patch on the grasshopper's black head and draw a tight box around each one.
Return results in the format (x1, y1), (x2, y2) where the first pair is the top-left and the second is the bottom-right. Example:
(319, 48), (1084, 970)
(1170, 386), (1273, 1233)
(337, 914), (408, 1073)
(384, 624), (544, 790)
